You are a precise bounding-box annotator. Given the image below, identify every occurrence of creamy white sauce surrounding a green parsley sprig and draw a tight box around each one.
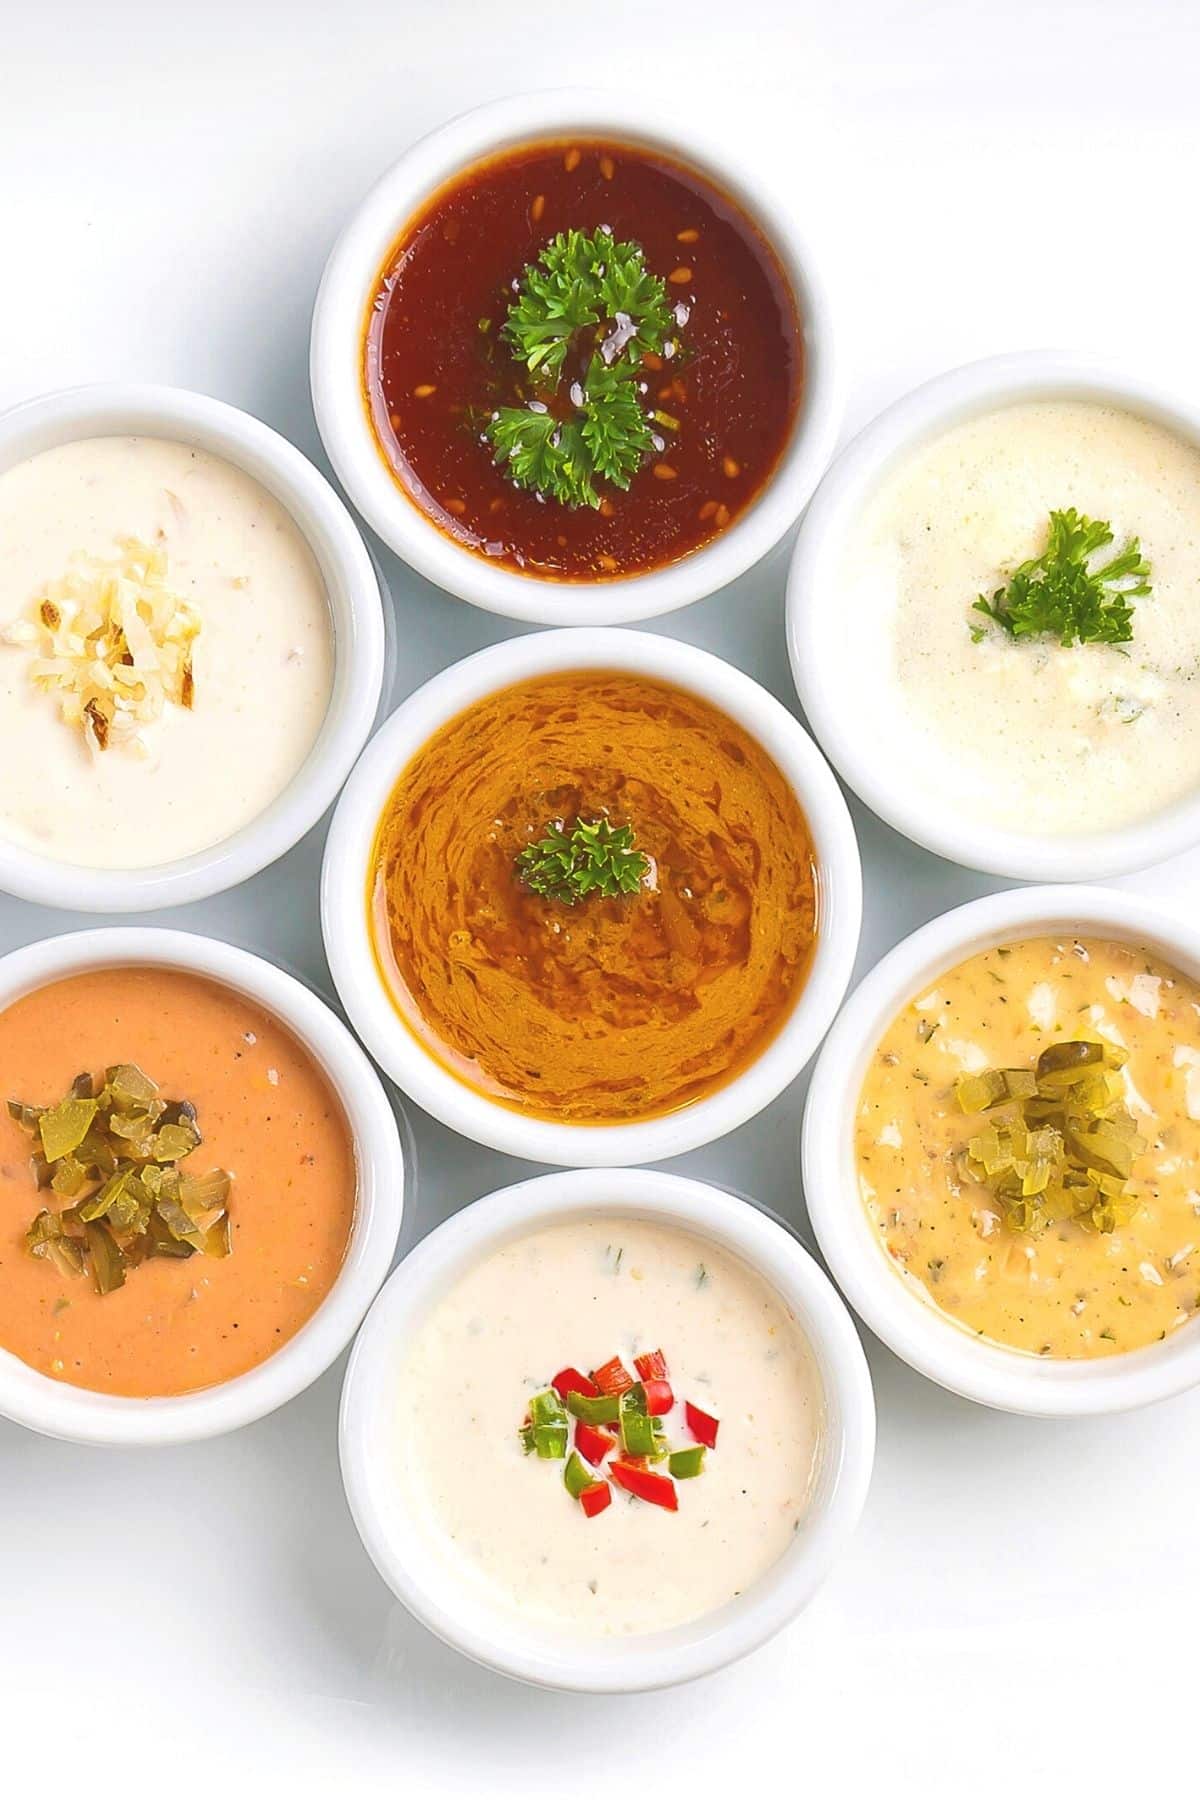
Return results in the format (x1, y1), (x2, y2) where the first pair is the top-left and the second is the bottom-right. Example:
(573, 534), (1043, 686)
(837, 401), (1200, 835)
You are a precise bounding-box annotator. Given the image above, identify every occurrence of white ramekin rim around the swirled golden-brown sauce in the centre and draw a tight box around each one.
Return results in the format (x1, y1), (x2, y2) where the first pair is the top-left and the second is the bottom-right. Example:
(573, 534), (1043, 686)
(320, 628), (862, 1166)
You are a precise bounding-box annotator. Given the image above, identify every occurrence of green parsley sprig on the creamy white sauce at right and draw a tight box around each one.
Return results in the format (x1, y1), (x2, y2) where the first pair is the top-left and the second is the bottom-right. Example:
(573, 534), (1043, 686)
(972, 506), (1150, 646)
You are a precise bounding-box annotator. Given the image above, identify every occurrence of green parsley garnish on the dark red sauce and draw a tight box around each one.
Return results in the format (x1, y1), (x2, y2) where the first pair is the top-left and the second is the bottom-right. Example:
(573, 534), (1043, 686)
(488, 230), (675, 508)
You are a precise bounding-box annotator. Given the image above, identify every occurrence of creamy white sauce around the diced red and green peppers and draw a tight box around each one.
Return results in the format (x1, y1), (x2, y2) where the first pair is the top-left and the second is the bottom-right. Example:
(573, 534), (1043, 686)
(396, 1217), (822, 1634)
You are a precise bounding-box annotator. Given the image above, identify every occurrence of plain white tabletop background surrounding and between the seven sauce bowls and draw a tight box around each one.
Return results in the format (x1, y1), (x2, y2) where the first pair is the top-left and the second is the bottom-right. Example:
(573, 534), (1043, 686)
(0, 0), (1200, 1800)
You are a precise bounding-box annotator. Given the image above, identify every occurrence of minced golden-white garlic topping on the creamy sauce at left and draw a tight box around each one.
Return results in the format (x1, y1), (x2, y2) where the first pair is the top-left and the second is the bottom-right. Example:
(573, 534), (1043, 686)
(0, 538), (200, 752)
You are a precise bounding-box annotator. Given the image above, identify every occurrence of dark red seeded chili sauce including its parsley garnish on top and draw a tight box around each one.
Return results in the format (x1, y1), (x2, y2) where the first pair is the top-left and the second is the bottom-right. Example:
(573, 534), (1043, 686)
(363, 142), (804, 581)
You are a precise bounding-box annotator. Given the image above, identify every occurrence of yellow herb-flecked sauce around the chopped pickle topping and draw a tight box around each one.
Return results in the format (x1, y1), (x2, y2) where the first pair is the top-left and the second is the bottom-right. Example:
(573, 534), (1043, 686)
(856, 938), (1200, 1357)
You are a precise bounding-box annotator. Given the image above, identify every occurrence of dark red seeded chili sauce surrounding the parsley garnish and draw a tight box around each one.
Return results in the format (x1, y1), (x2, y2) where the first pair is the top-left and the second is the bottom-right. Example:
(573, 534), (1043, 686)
(363, 142), (802, 581)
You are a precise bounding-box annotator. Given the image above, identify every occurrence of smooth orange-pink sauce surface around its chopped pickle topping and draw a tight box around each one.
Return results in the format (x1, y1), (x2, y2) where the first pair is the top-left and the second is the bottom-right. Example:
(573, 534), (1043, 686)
(0, 968), (356, 1397)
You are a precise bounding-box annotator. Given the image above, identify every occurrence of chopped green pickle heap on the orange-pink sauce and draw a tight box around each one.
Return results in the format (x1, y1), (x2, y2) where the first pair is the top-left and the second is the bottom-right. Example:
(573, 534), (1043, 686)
(9, 1062), (232, 1294)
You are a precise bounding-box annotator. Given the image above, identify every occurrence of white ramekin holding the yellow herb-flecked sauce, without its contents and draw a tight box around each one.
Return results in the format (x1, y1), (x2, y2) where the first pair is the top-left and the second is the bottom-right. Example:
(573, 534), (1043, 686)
(802, 887), (1200, 1418)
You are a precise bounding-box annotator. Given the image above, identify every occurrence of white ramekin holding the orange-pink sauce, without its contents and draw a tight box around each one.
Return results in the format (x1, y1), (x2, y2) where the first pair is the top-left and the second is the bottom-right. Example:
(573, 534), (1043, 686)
(0, 927), (405, 1445)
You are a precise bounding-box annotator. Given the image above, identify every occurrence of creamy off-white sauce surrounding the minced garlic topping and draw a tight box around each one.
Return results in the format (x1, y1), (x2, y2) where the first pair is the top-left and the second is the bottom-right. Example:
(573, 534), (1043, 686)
(0, 437), (333, 869)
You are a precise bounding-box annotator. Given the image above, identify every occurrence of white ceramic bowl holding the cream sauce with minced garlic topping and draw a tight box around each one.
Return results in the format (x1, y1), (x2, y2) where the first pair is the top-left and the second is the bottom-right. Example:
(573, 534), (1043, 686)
(0, 385), (385, 913)
